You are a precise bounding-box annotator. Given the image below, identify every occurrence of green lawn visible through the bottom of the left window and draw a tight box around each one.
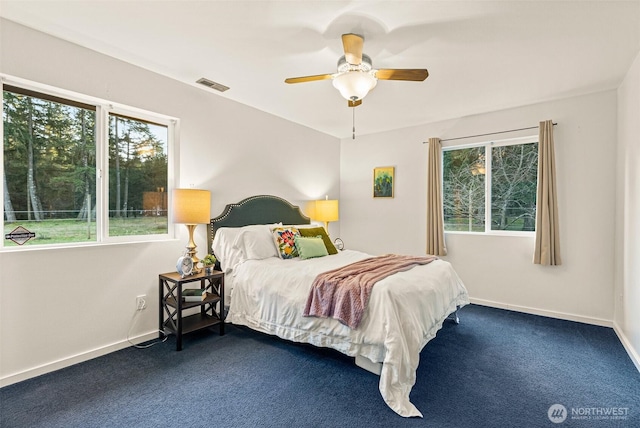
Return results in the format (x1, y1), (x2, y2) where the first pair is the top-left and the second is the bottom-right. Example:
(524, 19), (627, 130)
(3, 217), (167, 247)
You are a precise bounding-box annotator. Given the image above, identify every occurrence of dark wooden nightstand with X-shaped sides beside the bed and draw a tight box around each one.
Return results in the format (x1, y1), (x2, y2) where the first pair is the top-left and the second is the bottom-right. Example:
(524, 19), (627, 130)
(158, 269), (224, 351)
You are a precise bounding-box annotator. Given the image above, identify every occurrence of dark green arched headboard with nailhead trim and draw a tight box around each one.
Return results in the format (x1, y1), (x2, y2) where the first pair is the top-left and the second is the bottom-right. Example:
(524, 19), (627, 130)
(207, 195), (311, 252)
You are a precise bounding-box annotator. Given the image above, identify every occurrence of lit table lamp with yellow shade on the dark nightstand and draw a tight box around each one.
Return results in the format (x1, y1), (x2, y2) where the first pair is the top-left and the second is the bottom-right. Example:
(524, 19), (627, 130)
(172, 189), (211, 270)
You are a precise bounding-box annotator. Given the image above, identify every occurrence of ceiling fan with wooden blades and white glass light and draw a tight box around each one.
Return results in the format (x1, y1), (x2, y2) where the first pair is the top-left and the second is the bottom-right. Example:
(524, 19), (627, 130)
(285, 33), (429, 107)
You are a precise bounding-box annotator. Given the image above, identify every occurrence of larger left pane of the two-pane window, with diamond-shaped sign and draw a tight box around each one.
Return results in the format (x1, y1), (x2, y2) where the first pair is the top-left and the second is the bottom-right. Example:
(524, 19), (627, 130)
(2, 90), (96, 246)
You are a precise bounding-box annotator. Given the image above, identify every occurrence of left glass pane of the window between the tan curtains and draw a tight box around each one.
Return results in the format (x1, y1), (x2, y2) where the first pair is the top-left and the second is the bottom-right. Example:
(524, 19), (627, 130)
(442, 147), (485, 232)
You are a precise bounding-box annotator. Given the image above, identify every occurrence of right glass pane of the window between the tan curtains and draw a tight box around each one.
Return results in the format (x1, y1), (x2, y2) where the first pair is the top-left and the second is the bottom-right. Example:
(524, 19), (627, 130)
(491, 143), (538, 231)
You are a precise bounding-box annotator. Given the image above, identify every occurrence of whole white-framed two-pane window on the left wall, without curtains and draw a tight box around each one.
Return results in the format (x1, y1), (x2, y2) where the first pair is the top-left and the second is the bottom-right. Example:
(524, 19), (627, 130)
(2, 78), (175, 247)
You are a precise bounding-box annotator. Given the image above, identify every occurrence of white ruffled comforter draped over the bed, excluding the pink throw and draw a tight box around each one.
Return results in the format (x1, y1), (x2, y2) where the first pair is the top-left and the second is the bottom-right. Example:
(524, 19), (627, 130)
(225, 250), (469, 417)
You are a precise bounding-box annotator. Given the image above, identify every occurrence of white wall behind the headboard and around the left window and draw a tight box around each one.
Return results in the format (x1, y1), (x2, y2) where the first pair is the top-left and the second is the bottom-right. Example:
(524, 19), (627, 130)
(0, 20), (340, 386)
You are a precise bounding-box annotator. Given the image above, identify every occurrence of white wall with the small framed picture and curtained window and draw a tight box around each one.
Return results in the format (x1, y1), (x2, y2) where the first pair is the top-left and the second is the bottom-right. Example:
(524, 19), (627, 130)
(340, 91), (616, 326)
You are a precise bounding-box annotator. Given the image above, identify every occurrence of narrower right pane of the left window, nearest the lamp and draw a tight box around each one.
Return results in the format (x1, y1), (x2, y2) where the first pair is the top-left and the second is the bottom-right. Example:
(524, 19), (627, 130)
(109, 115), (169, 236)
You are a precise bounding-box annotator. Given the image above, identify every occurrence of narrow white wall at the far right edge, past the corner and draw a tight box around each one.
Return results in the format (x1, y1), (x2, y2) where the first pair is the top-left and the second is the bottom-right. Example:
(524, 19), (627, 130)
(615, 54), (640, 370)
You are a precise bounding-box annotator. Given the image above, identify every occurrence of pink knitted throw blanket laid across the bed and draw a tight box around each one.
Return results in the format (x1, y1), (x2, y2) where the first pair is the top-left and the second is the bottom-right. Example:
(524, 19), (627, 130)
(303, 254), (437, 328)
